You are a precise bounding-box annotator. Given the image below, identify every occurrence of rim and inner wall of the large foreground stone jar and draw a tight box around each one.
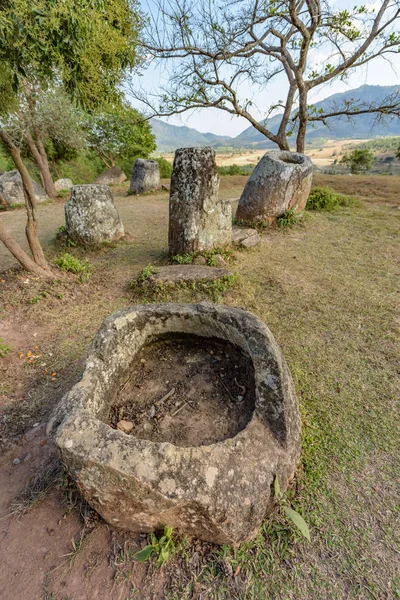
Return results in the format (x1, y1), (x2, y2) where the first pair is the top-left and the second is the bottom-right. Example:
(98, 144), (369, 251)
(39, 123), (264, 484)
(47, 303), (298, 451)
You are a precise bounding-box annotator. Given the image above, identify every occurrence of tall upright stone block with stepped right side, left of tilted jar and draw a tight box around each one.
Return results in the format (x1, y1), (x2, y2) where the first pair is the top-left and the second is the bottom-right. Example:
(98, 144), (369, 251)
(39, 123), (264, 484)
(168, 148), (232, 255)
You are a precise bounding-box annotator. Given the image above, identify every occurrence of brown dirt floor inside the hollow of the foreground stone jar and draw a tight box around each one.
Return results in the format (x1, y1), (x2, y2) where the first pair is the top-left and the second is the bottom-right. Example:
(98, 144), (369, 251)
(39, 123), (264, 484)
(111, 336), (255, 446)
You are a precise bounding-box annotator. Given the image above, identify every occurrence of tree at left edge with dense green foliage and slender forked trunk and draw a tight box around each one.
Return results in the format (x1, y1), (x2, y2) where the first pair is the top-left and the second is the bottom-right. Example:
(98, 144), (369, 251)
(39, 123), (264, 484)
(0, 0), (141, 277)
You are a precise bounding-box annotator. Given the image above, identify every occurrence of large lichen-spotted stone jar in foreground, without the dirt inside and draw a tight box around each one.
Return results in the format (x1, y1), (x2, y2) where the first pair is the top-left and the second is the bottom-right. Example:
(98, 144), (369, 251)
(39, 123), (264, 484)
(48, 304), (300, 544)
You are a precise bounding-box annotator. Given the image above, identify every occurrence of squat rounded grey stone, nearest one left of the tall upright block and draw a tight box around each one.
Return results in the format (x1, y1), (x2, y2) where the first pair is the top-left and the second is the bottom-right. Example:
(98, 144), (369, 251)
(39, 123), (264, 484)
(65, 183), (124, 246)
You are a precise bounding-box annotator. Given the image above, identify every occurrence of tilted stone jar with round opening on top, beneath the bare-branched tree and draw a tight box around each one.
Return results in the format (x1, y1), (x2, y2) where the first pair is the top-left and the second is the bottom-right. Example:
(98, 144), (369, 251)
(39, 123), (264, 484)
(236, 150), (312, 222)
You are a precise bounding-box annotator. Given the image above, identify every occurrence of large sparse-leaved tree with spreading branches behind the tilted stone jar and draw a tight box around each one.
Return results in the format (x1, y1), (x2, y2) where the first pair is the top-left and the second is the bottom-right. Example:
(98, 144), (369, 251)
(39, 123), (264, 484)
(132, 0), (400, 152)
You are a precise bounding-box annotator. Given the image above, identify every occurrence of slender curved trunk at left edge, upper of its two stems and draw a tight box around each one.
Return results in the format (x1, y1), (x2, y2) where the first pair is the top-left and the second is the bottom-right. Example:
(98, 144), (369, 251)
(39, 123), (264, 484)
(0, 129), (47, 269)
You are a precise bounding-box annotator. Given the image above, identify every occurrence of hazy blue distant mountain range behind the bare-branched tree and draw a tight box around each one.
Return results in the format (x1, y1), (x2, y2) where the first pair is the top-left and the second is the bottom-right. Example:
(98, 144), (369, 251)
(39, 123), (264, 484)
(151, 85), (400, 152)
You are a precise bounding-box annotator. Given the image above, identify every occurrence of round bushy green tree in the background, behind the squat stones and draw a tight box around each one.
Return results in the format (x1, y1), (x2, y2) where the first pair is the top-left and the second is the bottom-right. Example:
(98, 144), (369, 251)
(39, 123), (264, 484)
(85, 102), (156, 169)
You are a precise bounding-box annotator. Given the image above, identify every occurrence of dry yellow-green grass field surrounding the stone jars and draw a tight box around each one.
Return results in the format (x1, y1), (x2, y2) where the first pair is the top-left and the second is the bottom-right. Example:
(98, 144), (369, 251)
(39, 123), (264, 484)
(0, 175), (400, 600)
